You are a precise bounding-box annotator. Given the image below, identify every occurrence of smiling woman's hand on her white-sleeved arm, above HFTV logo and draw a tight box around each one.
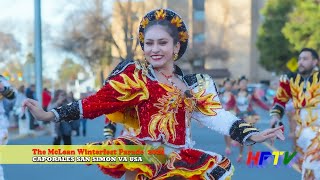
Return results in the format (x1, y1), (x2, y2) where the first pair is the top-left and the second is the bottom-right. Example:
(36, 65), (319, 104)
(250, 126), (285, 142)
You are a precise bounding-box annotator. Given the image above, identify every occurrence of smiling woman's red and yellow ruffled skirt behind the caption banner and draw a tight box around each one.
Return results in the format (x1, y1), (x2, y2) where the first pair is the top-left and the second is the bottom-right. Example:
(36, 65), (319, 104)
(87, 136), (234, 180)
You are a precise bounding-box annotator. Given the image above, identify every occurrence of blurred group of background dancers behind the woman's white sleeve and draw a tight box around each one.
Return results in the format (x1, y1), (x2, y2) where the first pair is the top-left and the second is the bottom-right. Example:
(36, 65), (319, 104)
(219, 76), (295, 162)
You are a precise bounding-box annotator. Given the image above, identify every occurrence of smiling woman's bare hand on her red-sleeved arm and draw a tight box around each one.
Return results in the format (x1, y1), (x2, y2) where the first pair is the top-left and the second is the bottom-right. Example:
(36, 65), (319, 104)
(22, 99), (54, 121)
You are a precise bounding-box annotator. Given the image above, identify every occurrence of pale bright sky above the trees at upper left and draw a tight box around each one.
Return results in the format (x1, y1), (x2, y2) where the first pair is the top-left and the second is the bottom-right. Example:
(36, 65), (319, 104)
(0, 0), (112, 79)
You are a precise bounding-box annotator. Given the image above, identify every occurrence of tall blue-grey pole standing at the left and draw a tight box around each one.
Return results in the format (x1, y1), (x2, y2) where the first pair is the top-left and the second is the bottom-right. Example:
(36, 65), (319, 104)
(34, 0), (42, 107)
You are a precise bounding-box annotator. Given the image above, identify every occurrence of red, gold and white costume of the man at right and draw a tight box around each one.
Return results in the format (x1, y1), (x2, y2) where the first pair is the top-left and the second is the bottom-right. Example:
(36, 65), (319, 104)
(271, 68), (320, 180)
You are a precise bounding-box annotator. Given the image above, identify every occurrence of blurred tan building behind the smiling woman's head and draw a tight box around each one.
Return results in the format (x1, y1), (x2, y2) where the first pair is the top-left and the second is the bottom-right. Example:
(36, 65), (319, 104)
(111, 0), (272, 81)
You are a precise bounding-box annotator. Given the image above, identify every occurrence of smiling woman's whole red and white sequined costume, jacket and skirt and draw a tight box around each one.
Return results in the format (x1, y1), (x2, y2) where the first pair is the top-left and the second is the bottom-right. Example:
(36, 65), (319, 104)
(53, 60), (258, 179)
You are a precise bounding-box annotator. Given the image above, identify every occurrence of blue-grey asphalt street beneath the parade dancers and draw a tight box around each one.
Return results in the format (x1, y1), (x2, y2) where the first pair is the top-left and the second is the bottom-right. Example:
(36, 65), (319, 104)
(3, 107), (301, 180)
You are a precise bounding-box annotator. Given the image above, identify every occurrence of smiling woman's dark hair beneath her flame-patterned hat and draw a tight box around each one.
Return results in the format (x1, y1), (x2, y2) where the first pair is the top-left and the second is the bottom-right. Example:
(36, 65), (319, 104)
(143, 20), (179, 44)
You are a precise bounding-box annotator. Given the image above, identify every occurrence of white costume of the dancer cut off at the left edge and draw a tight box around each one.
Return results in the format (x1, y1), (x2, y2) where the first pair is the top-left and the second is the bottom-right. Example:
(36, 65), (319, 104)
(0, 75), (15, 179)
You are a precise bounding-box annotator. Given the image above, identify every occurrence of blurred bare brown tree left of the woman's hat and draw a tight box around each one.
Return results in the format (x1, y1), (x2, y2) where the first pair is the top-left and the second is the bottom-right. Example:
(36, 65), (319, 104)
(56, 0), (143, 85)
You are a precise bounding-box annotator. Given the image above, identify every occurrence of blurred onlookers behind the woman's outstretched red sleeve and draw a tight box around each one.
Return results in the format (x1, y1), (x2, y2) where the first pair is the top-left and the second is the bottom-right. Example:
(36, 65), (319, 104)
(3, 84), (90, 145)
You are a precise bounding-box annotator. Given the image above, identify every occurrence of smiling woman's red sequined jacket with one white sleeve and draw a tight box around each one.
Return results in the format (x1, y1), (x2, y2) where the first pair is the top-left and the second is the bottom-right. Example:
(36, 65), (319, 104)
(53, 61), (257, 147)
